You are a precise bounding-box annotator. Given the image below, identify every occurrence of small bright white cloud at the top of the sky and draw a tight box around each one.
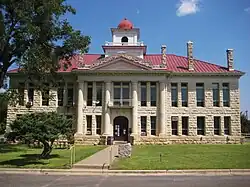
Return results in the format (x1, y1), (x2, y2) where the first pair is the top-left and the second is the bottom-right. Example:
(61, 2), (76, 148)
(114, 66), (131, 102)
(176, 0), (200, 17)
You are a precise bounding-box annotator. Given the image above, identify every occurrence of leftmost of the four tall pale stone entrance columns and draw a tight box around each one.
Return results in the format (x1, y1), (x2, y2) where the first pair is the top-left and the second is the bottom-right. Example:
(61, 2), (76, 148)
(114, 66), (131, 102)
(76, 82), (84, 135)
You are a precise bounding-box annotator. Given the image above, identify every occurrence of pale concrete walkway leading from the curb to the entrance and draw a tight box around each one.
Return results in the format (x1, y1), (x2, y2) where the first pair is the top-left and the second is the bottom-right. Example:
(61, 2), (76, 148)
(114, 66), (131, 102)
(73, 145), (118, 169)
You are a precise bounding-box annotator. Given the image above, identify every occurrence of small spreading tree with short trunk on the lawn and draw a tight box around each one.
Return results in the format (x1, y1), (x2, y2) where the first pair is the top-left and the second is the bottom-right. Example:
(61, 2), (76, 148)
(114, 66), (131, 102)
(9, 112), (74, 158)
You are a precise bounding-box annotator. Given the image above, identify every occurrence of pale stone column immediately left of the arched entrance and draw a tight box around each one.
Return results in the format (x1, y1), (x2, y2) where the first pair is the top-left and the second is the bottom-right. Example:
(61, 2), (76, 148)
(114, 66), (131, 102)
(103, 82), (111, 135)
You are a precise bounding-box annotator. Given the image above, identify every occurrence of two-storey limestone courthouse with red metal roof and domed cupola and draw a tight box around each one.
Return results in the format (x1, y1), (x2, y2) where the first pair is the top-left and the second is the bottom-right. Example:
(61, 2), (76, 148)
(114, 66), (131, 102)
(7, 19), (244, 144)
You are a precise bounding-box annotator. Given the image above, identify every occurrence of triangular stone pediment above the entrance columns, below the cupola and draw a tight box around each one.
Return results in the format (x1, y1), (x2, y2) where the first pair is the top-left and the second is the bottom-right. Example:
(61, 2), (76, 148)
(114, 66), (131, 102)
(90, 55), (152, 71)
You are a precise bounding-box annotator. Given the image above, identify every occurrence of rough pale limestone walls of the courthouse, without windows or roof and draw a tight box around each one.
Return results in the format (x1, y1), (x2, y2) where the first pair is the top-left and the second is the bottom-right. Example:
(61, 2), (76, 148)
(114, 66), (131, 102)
(7, 75), (241, 144)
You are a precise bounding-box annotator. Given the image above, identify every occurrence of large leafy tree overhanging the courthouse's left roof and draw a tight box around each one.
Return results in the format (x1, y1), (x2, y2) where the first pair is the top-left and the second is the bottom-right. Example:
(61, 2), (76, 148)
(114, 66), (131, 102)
(0, 0), (90, 89)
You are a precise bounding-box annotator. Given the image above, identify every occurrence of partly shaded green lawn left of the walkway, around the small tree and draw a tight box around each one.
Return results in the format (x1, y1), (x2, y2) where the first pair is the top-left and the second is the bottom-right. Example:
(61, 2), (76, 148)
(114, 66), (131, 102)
(0, 144), (105, 168)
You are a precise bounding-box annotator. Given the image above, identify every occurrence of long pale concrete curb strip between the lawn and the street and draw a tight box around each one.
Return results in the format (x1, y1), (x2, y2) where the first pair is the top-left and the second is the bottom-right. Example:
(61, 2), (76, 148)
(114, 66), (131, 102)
(0, 168), (250, 176)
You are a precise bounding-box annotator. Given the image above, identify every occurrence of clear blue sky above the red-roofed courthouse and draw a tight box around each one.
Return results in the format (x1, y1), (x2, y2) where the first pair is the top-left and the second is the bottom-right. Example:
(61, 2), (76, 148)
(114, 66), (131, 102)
(66, 0), (250, 111)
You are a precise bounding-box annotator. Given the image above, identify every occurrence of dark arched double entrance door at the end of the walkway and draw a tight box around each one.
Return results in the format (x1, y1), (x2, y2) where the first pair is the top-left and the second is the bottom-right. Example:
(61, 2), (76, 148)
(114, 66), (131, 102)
(114, 116), (128, 141)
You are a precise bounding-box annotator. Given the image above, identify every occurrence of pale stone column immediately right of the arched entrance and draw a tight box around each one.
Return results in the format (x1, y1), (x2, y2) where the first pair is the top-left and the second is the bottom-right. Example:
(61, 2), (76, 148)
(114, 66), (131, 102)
(132, 82), (138, 136)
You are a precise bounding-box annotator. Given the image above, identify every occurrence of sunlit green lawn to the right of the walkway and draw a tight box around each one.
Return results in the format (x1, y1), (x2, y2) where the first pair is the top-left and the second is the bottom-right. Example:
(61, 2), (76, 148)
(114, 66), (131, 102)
(112, 144), (250, 170)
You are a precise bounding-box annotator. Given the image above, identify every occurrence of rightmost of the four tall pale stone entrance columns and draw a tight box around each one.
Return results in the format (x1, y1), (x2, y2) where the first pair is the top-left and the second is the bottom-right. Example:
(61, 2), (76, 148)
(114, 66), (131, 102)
(159, 82), (166, 136)
